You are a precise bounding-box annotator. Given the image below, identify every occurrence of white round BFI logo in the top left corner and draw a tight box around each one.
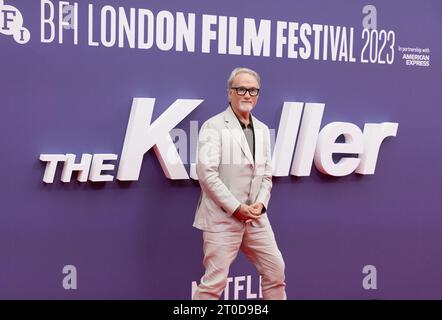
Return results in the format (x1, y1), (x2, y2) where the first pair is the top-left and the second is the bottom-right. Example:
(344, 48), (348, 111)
(0, 0), (31, 44)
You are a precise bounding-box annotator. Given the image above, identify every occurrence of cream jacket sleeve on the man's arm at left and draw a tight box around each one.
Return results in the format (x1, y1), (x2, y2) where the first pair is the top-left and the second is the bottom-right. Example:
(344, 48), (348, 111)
(196, 122), (241, 215)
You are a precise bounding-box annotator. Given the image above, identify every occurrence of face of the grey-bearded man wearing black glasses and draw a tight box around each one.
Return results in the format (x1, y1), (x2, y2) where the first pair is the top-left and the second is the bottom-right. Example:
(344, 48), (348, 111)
(229, 73), (259, 113)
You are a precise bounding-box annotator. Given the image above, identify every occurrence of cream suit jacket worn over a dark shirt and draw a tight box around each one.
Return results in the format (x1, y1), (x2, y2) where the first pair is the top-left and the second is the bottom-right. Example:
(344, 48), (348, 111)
(193, 106), (272, 232)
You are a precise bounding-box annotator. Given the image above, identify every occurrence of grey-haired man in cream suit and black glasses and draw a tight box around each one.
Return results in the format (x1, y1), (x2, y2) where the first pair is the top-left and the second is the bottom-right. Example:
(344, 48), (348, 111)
(193, 68), (286, 300)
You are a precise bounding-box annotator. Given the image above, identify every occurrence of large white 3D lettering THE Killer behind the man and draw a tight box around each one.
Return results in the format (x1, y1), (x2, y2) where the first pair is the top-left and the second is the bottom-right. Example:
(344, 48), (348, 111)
(40, 98), (398, 183)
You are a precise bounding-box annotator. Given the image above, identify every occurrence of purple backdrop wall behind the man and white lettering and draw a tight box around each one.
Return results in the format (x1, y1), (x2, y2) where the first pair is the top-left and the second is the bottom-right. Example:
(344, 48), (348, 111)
(0, 0), (442, 299)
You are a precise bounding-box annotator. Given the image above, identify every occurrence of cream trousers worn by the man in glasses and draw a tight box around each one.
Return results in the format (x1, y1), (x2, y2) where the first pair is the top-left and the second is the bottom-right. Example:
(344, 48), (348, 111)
(193, 223), (287, 300)
